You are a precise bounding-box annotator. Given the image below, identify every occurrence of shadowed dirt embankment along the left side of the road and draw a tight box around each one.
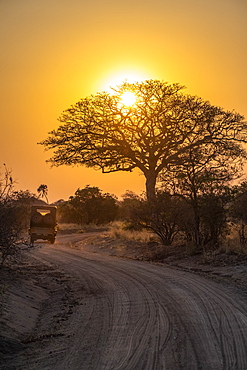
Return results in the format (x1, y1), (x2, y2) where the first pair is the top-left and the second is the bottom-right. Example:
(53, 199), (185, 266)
(0, 256), (80, 362)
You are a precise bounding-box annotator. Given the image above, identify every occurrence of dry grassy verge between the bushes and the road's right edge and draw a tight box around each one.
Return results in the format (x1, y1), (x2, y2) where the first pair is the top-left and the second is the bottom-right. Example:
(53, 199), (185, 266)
(51, 222), (247, 294)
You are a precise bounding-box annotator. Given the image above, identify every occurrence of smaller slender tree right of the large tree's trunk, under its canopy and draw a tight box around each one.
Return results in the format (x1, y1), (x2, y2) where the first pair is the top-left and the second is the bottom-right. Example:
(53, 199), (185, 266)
(160, 143), (240, 249)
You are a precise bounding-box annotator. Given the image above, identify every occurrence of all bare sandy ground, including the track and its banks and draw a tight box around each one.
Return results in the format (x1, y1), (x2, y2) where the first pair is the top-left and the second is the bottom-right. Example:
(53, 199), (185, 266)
(0, 233), (247, 370)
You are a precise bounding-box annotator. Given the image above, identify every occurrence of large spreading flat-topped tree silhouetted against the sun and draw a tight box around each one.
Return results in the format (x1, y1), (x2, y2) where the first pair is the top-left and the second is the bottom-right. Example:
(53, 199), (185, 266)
(41, 80), (247, 203)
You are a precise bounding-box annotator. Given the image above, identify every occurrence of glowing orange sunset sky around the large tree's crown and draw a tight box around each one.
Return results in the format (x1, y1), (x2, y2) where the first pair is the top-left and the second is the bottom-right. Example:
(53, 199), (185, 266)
(0, 0), (247, 202)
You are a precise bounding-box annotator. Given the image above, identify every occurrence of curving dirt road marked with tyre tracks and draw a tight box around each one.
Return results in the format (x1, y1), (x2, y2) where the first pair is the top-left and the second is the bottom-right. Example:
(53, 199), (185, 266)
(0, 239), (247, 370)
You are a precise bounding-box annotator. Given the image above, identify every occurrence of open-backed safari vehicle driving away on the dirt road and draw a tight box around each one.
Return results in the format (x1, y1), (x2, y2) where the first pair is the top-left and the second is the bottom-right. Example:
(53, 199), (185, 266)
(29, 206), (57, 244)
